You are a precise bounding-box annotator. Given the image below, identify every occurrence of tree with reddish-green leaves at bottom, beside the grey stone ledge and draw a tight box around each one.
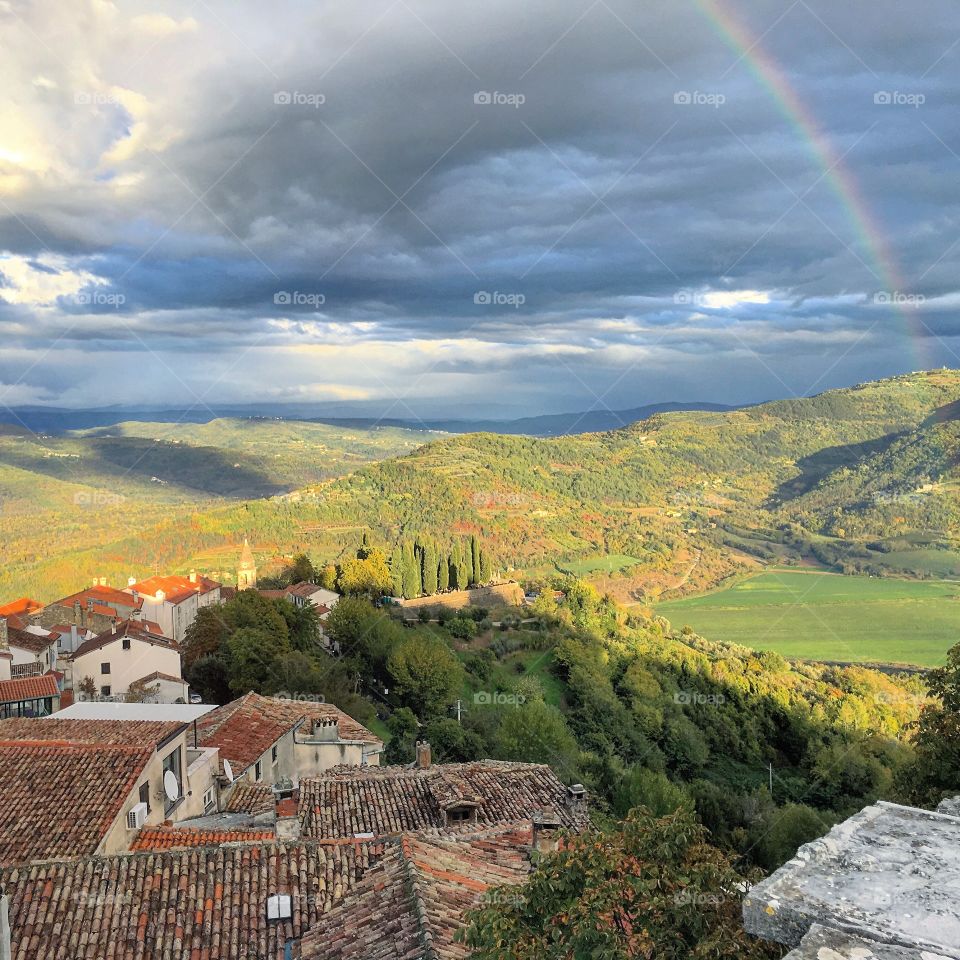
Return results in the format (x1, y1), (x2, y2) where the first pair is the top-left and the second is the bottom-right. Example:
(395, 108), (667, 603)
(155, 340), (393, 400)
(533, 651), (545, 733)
(459, 807), (781, 960)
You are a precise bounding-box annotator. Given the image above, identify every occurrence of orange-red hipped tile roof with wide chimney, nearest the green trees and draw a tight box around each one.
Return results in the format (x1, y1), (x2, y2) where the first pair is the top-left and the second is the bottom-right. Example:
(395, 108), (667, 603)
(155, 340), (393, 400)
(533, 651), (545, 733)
(197, 693), (380, 777)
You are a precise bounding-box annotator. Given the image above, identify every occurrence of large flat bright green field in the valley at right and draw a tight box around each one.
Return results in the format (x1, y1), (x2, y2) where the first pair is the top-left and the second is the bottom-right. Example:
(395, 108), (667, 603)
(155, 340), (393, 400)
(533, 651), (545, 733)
(657, 572), (960, 666)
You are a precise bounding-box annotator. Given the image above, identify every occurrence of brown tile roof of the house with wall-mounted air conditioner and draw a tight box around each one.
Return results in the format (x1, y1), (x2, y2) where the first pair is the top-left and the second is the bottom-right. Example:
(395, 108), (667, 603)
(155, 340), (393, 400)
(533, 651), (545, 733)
(0, 740), (153, 864)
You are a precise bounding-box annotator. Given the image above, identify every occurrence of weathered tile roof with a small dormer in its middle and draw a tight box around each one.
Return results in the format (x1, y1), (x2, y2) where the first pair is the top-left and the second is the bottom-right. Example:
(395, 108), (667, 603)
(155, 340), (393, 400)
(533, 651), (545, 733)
(300, 760), (587, 840)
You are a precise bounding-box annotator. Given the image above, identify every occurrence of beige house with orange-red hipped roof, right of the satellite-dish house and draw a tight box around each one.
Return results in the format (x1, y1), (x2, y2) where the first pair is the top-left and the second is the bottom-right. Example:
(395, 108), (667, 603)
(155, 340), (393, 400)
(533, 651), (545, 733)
(197, 693), (383, 786)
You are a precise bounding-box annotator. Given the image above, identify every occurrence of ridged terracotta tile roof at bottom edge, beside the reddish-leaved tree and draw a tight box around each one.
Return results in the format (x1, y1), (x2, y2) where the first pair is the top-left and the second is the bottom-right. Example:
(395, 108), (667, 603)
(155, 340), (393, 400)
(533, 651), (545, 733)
(301, 827), (531, 960)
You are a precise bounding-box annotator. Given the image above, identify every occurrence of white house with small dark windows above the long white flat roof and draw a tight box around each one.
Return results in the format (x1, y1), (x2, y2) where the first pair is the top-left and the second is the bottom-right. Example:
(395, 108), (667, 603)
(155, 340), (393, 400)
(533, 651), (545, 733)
(66, 620), (189, 703)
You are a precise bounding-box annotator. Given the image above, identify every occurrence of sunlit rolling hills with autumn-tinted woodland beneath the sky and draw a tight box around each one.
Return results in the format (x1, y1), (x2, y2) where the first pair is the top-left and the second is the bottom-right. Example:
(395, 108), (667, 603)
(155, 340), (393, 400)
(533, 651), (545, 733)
(0, 370), (960, 624)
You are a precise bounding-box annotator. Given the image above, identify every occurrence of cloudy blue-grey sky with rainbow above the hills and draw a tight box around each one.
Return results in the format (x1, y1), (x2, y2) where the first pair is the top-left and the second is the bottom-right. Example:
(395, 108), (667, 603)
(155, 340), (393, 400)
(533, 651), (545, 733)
(0, 0), (960, 419)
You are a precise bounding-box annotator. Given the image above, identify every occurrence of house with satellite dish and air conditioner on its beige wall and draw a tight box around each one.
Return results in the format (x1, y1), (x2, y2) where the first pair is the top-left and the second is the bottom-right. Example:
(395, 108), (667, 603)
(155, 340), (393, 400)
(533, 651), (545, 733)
(0, 716), (219, 863)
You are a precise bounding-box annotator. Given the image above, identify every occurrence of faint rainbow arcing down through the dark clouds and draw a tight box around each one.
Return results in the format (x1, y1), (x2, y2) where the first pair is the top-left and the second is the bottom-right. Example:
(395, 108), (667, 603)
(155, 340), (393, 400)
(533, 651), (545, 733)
(693, 0), (928, 366)
